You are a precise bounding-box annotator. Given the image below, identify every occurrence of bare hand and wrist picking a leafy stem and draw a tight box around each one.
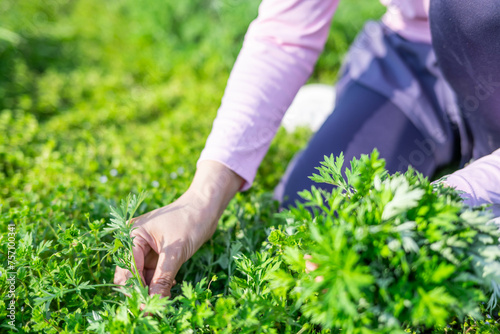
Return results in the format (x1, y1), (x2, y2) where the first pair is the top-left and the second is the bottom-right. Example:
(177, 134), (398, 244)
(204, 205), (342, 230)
(114, 161), (243, 297)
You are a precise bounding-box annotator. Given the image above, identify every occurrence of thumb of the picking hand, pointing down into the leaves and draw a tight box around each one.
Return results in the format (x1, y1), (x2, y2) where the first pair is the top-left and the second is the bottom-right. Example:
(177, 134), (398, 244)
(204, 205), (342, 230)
(149, 250), (182, 297)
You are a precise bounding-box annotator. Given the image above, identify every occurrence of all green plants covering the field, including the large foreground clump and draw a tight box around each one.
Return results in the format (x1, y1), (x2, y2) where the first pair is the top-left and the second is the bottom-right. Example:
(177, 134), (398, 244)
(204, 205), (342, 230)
(0, 0), (500, 333)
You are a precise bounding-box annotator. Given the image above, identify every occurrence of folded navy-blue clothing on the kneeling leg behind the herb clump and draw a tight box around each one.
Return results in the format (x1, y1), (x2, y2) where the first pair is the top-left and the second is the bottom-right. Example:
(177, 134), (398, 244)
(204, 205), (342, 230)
(277, 22), (460, 207)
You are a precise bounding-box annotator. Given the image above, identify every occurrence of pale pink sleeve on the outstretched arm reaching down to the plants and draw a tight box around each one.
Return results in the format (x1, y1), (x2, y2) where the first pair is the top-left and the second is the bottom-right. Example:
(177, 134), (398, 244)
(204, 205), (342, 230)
(198, 0), (338, 190)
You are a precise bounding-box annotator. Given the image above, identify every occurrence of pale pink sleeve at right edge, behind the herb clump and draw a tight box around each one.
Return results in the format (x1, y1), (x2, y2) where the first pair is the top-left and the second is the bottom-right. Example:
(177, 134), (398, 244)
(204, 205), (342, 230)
(446, 149), (500, 216)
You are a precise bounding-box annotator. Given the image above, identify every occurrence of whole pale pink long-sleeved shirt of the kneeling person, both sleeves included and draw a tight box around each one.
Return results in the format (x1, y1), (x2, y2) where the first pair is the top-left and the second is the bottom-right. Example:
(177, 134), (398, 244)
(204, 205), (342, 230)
(198, 0), (500, 211)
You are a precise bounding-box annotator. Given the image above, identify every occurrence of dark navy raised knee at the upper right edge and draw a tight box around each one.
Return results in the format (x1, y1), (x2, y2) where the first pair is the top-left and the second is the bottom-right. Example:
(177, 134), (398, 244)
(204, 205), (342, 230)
(429, 0), (500, 159)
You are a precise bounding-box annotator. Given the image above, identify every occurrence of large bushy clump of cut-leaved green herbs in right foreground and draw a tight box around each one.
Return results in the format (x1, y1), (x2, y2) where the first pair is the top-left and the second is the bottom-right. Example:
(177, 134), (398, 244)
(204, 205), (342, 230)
(269, 151), (500, 333)
